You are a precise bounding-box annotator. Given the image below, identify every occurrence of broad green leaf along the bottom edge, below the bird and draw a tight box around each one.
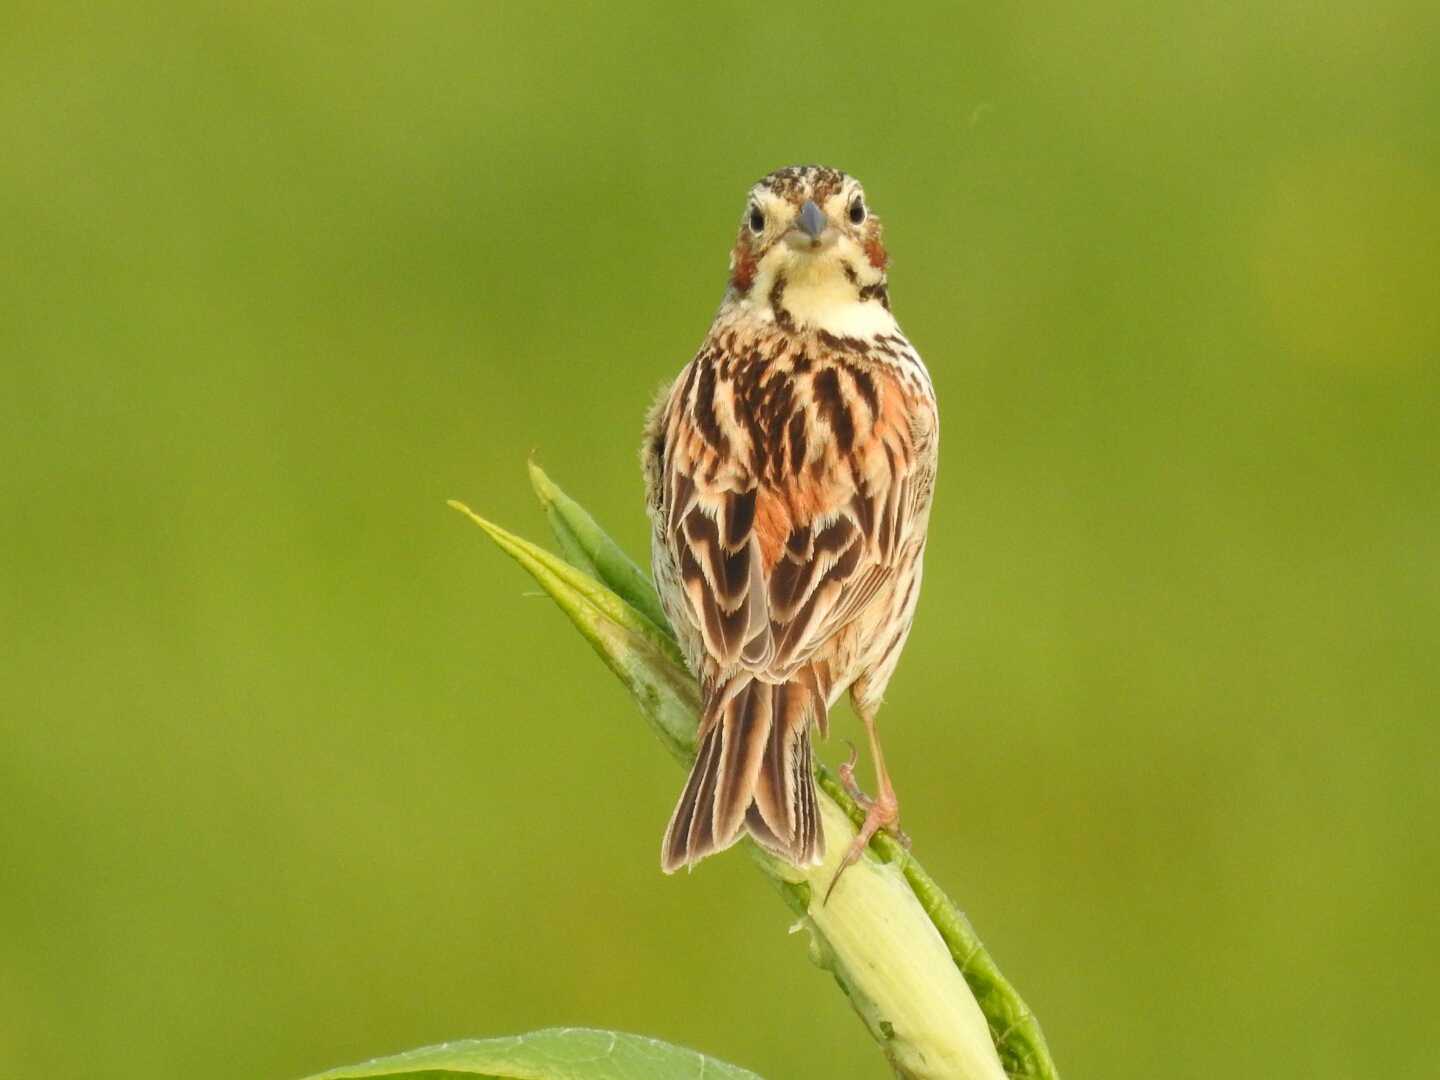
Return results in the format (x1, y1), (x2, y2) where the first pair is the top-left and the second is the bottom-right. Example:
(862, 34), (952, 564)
(310, 1028), (760, 1080)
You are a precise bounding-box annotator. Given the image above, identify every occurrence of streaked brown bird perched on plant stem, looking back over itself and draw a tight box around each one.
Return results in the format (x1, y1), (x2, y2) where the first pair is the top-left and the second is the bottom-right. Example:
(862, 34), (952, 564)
(641, 166), (939, 899)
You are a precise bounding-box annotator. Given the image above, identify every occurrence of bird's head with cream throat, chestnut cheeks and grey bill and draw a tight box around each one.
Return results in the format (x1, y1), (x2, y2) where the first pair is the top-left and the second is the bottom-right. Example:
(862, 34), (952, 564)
(727, 166), (890, 333)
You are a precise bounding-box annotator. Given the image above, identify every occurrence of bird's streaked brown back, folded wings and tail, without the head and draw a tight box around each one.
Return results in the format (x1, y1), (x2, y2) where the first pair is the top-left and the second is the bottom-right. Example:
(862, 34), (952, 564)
(645, 354), (933, 870)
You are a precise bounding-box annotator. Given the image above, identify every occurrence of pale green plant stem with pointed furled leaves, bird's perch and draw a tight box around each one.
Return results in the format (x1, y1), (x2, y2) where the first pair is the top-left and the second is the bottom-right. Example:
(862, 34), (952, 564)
(451, 483), (1057, 1080)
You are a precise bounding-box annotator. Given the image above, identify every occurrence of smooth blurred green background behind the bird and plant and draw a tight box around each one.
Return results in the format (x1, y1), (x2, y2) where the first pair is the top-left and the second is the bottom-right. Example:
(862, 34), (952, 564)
(0, 0), (1440, 1080)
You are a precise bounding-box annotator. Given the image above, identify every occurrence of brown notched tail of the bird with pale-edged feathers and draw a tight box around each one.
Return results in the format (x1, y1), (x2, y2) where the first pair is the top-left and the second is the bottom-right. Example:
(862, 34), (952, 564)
(660, 670), (825, 874)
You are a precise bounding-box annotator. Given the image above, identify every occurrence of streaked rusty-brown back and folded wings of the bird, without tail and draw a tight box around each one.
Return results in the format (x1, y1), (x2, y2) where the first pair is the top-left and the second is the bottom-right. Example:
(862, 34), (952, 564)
(655, 355), (917, 685)
